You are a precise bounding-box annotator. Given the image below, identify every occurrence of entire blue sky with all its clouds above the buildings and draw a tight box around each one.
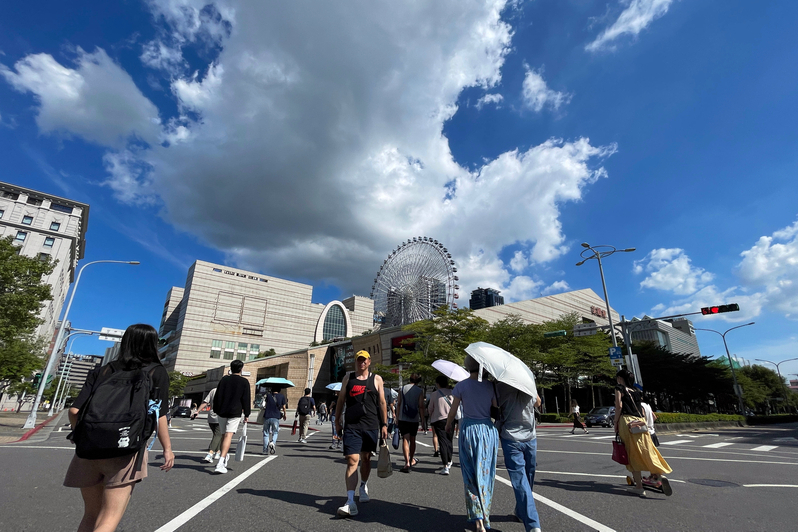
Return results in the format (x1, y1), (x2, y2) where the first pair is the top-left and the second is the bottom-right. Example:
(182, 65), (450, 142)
(0, 0), (798, 378)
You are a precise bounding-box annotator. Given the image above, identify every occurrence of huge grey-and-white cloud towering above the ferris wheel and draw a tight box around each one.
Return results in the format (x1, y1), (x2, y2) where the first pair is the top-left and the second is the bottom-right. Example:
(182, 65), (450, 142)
(9, 0), (616, 300)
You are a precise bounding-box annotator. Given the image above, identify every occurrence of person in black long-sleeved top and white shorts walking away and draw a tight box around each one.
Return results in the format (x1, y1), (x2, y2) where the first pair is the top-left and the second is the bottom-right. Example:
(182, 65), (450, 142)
(213, 360), (252, 473)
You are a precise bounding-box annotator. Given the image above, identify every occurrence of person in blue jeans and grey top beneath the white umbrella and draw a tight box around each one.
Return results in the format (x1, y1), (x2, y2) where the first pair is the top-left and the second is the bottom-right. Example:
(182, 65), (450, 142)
(496, 382), (540, 532)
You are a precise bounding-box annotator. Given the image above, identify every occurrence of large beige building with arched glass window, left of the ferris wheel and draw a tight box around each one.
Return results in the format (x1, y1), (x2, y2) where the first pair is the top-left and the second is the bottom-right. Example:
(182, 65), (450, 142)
(159, 260), (374, 375)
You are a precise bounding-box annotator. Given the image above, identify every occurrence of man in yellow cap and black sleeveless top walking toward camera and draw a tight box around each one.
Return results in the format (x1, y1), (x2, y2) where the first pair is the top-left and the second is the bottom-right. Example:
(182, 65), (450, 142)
(335, 350), (388, 517)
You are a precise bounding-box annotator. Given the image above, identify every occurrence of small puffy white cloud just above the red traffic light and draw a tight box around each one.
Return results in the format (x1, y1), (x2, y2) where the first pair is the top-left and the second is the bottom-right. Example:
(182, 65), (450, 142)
(633, 248), (714, 295)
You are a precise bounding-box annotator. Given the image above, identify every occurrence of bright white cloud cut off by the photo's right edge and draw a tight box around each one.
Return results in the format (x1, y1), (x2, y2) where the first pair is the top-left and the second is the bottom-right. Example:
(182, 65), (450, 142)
(738, 218), (798, 318)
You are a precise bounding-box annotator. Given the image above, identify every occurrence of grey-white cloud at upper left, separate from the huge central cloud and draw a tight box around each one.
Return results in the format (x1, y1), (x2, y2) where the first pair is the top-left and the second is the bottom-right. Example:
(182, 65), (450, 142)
(0, 49), (160, 147)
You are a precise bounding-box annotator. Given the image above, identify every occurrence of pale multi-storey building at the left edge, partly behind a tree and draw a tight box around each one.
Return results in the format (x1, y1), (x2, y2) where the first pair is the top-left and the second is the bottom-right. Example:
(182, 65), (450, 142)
(0, 182), (89, 341)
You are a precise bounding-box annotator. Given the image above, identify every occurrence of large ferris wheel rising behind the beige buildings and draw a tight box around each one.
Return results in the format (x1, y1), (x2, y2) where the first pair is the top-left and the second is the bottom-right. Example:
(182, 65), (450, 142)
(371, 236), (460, 327)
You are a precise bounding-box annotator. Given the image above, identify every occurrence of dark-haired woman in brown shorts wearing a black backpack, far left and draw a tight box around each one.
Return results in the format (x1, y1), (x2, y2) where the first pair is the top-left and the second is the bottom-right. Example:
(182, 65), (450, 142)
(64, 324), (175, 532)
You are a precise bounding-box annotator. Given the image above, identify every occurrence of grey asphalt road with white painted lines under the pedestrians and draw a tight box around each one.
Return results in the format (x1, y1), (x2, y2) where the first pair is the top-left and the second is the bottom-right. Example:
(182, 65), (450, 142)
(0, 419), (798, 532)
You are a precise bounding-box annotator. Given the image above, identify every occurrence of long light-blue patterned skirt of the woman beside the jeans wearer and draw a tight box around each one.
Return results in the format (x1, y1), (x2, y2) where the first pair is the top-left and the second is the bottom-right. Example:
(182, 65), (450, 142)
(459, 418), (499, 528)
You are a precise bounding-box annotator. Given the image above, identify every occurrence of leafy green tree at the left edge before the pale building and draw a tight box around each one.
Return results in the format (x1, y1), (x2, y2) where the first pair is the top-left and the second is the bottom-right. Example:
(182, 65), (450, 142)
(0, 236), (56, 391)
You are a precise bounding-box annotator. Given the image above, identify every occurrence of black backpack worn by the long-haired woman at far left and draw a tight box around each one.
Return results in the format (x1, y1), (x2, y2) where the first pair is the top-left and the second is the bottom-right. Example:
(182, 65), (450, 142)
(72, 362), (160, 470)
